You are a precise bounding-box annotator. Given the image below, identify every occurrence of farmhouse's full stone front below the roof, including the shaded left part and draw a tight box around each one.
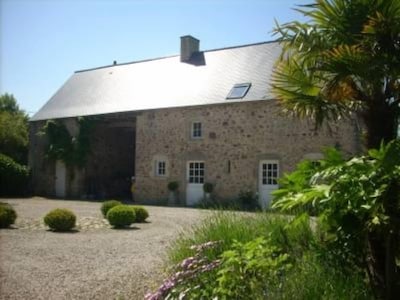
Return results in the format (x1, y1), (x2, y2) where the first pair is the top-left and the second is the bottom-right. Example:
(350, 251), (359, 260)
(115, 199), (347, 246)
(30, 101), (360, 205)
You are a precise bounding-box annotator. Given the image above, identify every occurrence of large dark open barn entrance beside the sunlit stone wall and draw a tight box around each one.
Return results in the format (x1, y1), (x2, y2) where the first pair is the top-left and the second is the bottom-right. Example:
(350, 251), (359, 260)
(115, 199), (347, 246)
(85, 113), (136, 199)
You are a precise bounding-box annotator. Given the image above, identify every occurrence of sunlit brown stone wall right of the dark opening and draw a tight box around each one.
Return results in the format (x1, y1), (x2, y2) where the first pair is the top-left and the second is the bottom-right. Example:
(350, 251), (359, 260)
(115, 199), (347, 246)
(136, 101), (360, 204)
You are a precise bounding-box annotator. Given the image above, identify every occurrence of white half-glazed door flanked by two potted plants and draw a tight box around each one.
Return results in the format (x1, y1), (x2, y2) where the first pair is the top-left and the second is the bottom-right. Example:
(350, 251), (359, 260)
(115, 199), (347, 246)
(186, 161), (205, 206)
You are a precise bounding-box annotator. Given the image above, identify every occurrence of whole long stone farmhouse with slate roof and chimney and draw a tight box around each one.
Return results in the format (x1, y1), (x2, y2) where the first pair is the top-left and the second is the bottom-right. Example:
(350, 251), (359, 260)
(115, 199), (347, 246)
(30, 36), (360, 206)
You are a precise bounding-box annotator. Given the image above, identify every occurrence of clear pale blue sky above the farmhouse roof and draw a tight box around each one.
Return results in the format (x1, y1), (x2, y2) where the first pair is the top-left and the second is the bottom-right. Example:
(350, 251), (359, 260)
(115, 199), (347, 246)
(0, 0), (311, 115)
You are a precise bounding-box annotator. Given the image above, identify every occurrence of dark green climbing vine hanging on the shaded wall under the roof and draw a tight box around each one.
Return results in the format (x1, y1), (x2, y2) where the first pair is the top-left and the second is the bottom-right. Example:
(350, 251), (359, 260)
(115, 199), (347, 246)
(41, 117), (94, 168)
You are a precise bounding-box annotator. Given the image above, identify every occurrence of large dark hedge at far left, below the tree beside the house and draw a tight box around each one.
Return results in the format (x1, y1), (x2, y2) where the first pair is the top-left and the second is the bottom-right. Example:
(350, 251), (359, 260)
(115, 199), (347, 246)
(0, 153), (29, 196)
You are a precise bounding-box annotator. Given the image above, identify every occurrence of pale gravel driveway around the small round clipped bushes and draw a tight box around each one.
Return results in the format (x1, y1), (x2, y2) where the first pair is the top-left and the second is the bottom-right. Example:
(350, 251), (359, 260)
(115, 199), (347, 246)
(0, 197), (206, 300)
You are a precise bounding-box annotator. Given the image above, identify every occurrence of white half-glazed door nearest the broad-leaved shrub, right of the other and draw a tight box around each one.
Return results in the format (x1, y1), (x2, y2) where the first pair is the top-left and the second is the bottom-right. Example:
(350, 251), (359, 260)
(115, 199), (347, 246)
(258, 160), (279, 209)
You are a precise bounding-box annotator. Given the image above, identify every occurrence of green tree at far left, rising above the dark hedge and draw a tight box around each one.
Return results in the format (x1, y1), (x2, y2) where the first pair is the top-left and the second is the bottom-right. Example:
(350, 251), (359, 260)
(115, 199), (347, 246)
(0, 93), (28, 164)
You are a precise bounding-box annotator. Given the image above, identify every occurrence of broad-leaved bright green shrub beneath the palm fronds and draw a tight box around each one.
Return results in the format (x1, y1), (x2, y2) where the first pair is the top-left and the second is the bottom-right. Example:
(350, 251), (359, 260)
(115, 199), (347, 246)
(274, 140), (400, 299)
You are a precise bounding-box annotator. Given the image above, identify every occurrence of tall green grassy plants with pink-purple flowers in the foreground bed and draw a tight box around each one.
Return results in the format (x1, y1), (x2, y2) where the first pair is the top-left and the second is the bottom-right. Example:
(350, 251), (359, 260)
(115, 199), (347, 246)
(155, 211), (372, 300)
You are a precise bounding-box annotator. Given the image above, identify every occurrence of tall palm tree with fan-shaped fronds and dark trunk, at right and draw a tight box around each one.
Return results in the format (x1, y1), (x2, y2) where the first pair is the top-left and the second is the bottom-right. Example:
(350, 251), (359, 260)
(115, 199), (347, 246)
(272, 0), (400, 299)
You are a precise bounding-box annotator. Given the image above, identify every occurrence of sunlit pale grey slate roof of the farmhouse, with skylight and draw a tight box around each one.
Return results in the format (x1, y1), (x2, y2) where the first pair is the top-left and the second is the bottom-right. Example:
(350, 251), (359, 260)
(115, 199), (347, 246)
(31, 42), (281, 121)
